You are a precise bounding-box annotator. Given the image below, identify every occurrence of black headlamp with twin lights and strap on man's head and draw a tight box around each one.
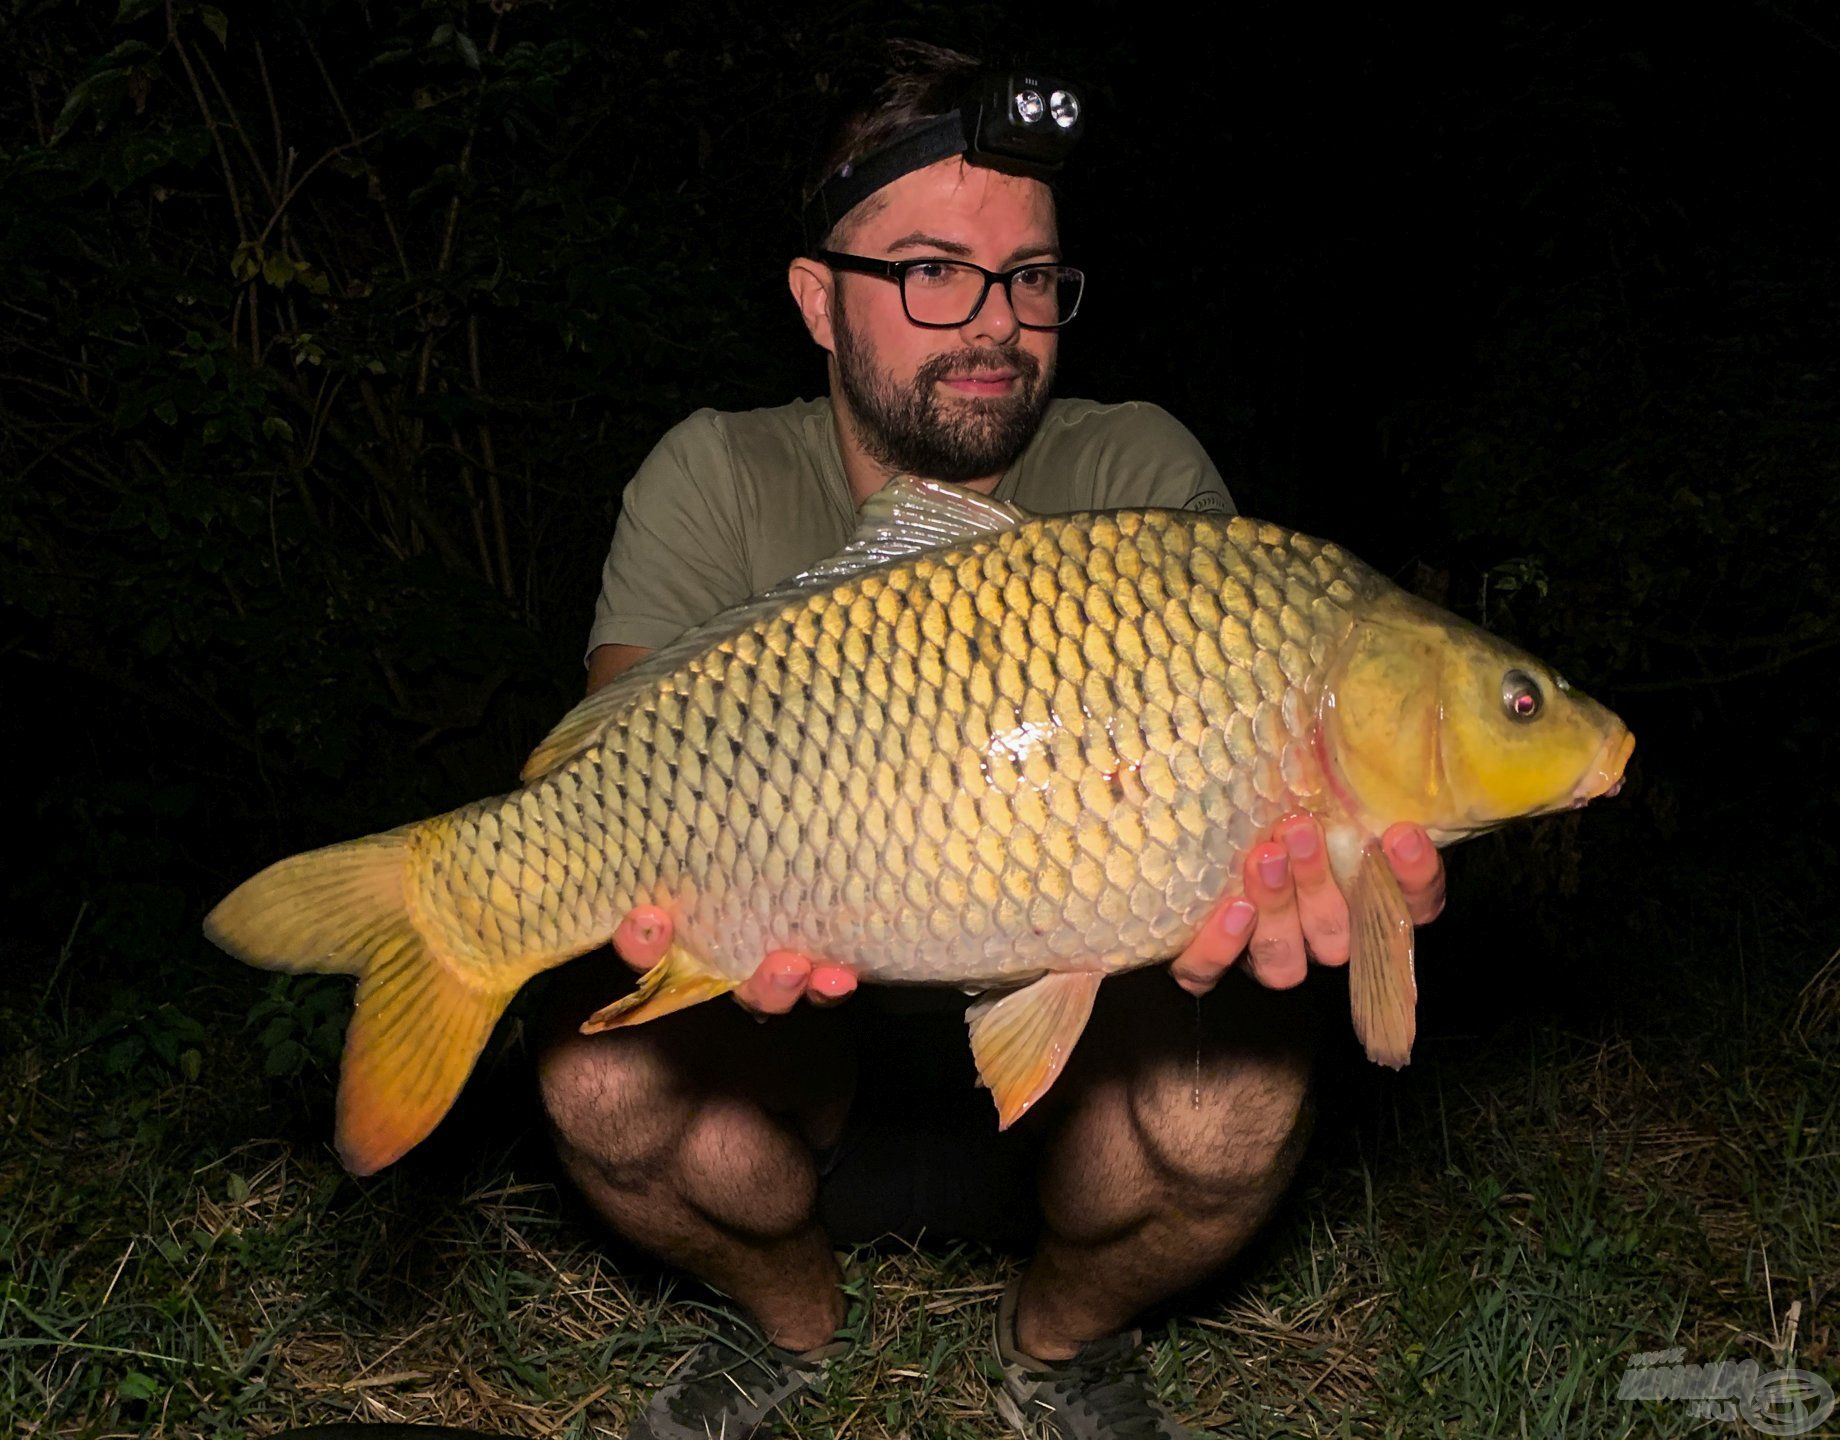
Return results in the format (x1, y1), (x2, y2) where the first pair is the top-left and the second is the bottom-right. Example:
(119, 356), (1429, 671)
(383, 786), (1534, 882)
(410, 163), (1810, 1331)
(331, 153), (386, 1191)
(804, 70), (1086, 245)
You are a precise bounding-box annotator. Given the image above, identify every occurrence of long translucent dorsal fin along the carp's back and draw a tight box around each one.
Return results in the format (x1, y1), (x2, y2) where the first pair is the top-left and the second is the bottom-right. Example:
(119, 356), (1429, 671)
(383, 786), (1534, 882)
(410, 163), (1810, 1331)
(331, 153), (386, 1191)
(519, 474), (1030, 785)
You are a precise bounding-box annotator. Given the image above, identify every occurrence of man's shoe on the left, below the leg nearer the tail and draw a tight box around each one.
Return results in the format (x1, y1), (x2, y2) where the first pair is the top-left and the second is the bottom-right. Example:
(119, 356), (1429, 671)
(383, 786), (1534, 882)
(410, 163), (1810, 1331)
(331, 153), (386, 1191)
(626, 1273), (872, 1440)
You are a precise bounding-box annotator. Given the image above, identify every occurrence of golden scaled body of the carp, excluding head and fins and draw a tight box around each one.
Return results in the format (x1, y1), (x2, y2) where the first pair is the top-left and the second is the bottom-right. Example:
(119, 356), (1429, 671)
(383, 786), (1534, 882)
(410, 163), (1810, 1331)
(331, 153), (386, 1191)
(416, 511), (1365, 988)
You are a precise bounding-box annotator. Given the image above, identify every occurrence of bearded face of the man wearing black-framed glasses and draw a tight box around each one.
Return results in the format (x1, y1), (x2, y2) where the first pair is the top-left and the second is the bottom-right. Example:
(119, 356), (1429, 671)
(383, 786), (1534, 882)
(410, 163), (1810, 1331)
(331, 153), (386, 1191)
(830, 158), (1060, 484)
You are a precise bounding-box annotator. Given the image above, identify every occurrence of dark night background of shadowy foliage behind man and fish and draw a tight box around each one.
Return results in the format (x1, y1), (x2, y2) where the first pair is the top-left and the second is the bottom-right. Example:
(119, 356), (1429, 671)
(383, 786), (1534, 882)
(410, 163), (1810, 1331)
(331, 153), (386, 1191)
(0, 0), (1840, 1092)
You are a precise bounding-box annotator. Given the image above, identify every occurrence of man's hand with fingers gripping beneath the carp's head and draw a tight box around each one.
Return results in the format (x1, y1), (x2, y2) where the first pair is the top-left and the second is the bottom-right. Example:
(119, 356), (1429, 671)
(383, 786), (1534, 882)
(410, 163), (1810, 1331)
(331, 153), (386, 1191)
(1170, 815), (1444, 995)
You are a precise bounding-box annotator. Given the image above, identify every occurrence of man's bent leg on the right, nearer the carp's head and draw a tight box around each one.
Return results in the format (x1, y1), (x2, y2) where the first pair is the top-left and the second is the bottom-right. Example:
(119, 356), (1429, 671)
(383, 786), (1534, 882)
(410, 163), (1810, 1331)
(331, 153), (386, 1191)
(1014, 971), (1314, 1361)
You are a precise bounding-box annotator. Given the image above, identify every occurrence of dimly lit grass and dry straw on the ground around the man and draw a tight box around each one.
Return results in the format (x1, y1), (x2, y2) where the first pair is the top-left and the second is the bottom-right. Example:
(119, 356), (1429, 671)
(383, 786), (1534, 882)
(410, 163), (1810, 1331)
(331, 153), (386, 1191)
(0, 893), (1840, 1440)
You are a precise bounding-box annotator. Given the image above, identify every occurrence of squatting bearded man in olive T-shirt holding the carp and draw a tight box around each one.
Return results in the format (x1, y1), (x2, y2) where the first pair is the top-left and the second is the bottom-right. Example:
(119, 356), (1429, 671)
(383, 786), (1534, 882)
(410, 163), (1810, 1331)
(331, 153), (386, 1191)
(539, 48), (1443, 1440)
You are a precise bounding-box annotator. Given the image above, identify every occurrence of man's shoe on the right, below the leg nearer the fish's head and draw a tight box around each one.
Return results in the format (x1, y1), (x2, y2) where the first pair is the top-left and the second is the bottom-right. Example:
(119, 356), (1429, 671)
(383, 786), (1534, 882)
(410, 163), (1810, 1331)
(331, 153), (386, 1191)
(997, 1280), (1203, 1440)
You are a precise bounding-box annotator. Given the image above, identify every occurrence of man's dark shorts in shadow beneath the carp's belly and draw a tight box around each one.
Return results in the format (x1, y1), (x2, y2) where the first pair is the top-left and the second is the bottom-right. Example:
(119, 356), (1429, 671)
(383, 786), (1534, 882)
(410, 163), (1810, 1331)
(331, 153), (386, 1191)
(543, 953), (1316, 1249)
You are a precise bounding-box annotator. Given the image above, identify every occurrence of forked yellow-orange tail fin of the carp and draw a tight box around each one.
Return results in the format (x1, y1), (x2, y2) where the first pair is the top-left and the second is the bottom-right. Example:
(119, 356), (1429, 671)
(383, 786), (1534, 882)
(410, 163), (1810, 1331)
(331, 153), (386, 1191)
(204, 829), (526, 1175)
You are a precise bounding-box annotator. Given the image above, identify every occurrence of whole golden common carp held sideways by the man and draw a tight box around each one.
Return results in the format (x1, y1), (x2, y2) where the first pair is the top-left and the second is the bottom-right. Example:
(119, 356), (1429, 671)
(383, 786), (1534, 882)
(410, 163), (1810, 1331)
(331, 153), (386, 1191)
(204, 480), (1634, 1173)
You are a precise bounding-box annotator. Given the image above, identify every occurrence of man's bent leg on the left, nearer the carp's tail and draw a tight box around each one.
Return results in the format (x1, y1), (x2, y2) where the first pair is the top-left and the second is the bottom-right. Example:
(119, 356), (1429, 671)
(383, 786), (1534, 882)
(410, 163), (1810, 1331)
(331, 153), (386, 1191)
(537, 956), (854, 1352)
